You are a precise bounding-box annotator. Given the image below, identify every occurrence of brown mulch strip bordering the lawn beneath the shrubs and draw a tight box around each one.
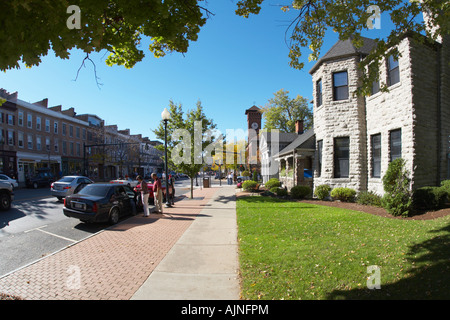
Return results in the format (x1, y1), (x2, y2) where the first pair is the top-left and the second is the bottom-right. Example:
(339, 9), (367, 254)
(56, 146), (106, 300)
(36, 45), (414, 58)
(236, 191), (450, 220)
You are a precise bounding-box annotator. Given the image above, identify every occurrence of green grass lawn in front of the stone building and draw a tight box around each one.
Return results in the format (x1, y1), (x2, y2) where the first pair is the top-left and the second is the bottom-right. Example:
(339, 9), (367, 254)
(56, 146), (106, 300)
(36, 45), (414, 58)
(237, 196), (450, 300)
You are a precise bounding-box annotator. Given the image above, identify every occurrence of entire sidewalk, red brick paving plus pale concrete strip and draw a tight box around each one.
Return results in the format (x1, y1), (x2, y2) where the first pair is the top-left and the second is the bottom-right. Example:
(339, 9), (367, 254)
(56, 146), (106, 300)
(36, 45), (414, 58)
(0, 186), (240, 300)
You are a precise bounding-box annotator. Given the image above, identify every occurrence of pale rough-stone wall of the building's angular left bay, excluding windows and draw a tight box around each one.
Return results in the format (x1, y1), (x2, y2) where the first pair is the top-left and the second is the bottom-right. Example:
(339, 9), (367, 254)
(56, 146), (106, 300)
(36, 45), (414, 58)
(313, 56), (367, 191)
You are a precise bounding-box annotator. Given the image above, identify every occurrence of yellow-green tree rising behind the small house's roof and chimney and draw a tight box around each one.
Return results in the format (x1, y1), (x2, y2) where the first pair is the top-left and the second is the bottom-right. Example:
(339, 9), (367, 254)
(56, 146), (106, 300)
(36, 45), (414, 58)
(261, 89), (313, 132)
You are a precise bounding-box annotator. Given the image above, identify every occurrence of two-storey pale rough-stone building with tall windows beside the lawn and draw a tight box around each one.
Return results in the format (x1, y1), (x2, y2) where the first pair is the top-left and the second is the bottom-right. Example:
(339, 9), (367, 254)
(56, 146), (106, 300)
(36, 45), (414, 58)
(310, 31), (450, 194)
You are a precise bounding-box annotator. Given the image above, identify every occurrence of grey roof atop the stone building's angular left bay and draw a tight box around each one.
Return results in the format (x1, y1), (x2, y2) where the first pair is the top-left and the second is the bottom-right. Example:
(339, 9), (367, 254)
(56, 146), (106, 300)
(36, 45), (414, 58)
(309, 37), (376, 74)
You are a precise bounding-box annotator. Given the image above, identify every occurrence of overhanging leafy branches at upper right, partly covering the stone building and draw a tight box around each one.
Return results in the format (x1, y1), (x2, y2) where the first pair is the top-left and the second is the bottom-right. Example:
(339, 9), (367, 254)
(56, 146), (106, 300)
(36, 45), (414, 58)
(236, 0), (450, 95)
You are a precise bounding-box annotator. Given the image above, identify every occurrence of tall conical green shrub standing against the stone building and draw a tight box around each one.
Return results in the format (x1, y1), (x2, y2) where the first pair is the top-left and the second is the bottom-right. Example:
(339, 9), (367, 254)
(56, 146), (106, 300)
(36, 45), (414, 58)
(382, 158), (412, 217)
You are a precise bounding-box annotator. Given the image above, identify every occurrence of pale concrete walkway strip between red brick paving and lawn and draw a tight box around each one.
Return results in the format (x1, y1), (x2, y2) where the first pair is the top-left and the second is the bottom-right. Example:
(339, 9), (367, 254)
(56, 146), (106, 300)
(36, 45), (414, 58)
(132, 187), (240, 300)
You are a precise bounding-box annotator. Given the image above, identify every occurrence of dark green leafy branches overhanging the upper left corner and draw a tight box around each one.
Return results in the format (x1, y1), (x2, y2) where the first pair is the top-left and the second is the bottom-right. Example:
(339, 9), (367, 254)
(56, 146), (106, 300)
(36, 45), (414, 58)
(0, 0), (210, 71)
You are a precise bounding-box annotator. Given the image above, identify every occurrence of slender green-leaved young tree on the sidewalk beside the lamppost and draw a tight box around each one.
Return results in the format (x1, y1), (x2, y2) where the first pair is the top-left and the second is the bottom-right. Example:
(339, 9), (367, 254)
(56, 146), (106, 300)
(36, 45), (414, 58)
(153, 100), (218, 198)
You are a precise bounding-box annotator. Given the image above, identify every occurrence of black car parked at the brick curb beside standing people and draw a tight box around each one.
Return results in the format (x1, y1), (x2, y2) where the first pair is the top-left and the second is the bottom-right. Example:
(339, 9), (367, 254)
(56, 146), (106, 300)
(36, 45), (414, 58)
(63, 183), (136, 224)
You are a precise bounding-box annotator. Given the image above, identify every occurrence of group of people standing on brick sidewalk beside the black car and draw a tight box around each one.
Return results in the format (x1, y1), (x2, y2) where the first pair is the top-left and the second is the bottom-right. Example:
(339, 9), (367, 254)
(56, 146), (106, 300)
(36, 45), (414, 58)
(134, 173), (175, 217)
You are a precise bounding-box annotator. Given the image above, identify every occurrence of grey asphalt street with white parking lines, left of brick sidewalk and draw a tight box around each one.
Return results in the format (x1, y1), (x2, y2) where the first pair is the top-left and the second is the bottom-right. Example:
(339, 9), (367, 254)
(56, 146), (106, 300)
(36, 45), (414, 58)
(0, 179), (195, 277)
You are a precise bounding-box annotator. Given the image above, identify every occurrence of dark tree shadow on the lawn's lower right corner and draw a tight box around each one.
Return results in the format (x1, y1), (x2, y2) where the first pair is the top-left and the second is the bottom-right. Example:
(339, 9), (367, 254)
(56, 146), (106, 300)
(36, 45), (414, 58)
(327, 224), (450, 300)
